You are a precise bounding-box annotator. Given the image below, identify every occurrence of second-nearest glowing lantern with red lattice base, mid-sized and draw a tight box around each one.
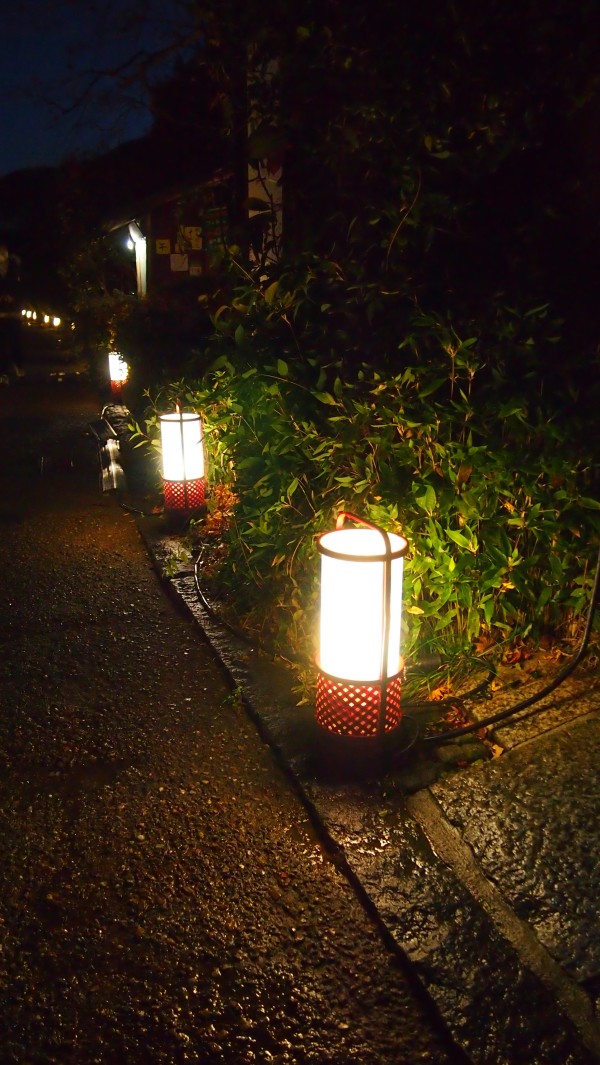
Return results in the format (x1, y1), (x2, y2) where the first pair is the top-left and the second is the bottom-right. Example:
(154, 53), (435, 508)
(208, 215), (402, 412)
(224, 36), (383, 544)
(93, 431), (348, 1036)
(160, 409), (206, 511)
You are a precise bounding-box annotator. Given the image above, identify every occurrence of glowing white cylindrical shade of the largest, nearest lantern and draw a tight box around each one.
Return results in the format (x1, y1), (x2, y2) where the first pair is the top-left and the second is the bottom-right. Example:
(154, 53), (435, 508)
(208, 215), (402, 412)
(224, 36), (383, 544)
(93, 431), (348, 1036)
(320, 528), (406, 682)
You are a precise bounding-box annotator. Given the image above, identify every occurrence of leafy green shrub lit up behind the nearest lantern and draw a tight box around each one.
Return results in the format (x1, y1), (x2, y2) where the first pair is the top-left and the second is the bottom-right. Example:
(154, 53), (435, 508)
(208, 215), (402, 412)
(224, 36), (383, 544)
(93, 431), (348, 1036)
(141, 271), (600, 673)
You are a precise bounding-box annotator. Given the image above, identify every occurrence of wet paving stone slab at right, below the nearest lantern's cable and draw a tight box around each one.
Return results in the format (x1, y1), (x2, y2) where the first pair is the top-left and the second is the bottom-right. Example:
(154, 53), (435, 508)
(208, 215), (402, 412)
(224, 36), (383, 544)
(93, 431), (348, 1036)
(432, 716), (600, 981)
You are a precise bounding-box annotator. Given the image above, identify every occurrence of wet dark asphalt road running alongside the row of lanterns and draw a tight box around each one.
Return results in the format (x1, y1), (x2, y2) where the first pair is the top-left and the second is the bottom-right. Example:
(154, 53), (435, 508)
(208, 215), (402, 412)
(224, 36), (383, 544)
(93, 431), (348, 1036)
(0, 376), (464, 1065)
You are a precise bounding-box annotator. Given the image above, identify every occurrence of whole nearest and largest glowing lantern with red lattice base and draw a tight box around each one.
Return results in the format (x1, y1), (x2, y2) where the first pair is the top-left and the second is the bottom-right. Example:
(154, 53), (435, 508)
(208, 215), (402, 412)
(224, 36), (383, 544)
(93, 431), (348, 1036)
(315, 512), (408, 737)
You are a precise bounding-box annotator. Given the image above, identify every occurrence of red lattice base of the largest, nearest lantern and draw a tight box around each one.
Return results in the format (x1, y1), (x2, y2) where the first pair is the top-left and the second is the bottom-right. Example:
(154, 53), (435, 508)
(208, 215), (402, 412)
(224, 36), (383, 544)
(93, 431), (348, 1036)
(314, 672), (402, 738)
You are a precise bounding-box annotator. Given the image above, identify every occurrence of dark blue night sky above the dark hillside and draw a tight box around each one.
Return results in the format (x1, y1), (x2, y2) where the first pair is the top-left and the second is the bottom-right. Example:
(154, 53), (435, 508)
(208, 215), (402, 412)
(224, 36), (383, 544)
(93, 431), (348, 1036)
(0, 0), (182, 177)
